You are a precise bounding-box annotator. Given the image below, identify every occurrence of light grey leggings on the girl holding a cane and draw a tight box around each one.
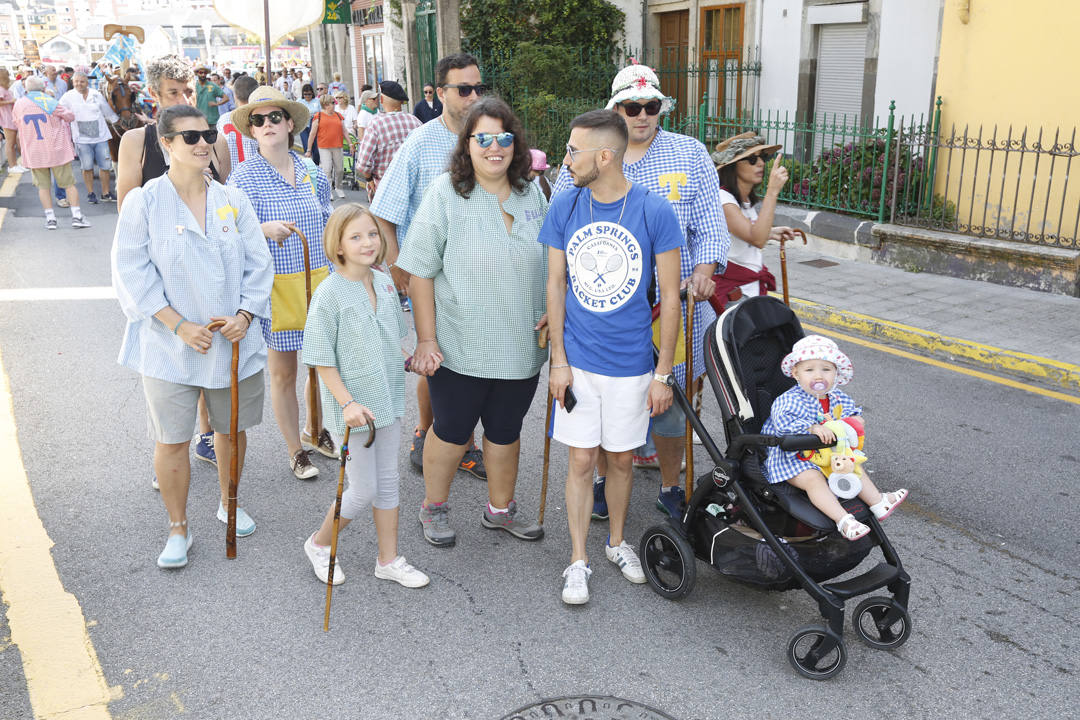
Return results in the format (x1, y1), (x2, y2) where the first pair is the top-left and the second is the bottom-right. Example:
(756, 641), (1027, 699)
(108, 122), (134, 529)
(334, 420), (402, 520)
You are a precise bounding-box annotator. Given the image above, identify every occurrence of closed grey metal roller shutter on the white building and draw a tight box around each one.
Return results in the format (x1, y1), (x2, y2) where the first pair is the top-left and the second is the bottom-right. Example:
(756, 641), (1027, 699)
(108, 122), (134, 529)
(814, 23), (866, 124)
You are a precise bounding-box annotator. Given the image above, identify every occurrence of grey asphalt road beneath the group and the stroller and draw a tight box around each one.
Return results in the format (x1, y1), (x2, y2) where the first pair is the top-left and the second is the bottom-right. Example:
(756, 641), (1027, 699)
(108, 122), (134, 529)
(0, 178), (1080, 720)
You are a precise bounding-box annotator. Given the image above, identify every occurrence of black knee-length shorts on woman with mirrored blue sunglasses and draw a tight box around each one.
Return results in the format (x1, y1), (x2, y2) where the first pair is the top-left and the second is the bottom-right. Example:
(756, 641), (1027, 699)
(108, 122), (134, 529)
(428, 367), (540, 445)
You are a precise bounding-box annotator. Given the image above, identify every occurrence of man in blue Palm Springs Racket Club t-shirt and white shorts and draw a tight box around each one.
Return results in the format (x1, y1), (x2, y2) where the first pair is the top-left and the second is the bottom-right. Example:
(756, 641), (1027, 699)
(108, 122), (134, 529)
(540, 110), (685, 604)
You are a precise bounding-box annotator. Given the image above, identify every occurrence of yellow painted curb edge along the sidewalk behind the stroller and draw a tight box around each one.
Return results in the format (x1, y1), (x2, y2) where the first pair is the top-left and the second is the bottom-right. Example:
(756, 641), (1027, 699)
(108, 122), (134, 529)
(791, 298), (1080, 392)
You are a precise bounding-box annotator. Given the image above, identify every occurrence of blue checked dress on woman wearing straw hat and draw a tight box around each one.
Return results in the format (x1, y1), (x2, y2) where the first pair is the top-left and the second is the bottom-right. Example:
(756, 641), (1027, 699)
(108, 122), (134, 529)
(229, 152), (333, 352)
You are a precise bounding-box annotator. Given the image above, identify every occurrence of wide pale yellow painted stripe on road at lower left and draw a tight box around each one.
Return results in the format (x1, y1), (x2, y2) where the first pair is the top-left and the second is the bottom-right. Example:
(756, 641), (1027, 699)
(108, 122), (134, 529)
(0, 345), (122, 720)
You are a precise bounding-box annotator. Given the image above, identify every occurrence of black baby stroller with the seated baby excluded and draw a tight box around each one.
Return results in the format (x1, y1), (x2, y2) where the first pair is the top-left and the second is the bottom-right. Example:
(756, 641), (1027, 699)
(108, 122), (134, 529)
(639, 297), (912, 680)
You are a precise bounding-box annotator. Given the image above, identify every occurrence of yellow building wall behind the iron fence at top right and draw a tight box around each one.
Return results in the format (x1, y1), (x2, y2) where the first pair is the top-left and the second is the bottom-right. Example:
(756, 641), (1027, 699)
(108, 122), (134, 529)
(936, 0), (1080, 247)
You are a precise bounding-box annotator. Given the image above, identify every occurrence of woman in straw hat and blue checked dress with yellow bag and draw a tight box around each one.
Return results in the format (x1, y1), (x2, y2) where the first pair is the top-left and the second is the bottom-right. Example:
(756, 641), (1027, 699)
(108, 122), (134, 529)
(229, 86), (336, 479)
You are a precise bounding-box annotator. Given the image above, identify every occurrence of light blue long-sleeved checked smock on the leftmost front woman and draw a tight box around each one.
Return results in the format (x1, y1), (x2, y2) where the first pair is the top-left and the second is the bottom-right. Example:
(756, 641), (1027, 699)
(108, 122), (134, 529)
(112, 175), (273, 388)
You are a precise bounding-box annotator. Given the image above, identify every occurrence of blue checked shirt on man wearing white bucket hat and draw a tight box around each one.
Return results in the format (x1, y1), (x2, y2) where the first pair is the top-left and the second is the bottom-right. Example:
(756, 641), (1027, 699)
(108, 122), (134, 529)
(552, 127), (731, 385)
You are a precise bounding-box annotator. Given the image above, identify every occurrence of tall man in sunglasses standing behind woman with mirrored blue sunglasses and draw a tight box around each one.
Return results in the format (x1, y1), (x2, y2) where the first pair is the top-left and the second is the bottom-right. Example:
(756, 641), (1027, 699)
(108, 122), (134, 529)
(372, 53), (487, 490)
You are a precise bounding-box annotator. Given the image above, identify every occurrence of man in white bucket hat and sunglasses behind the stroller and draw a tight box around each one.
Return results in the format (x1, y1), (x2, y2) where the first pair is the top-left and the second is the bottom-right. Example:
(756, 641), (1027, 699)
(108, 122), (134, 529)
(553, 60), (731, 519)
